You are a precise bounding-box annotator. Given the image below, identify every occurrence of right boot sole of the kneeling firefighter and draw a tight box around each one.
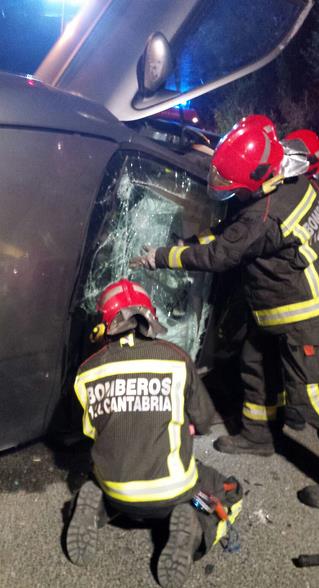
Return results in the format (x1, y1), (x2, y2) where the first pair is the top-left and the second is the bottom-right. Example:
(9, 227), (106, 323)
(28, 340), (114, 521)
(157, 503), (202, 588)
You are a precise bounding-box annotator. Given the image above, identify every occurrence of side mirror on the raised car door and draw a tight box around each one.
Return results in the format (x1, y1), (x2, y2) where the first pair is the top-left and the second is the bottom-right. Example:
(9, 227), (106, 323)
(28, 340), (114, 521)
(137, 32), (173, 97)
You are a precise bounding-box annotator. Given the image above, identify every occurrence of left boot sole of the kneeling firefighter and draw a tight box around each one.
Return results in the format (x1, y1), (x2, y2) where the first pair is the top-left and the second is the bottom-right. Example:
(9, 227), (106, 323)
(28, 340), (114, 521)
(66, 481), (103, 566)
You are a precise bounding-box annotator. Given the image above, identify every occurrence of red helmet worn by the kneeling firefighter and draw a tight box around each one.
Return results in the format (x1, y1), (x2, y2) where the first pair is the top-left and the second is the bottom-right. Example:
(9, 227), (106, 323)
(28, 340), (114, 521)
(96, 279), (166, 339)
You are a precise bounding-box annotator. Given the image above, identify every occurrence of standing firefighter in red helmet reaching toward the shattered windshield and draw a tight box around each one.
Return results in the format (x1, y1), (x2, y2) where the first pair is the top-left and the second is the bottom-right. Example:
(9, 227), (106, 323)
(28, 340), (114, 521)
(131, 121), (319, 498)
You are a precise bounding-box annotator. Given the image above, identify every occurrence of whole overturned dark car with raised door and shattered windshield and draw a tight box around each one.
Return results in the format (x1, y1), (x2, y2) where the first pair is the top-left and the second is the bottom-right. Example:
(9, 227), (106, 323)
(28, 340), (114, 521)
(0, 0), (312, 450)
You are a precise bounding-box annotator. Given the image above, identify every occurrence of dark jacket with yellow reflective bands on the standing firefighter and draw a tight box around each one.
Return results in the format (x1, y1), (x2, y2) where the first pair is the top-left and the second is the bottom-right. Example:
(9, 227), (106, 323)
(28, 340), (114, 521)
(155, 176), (319, 327)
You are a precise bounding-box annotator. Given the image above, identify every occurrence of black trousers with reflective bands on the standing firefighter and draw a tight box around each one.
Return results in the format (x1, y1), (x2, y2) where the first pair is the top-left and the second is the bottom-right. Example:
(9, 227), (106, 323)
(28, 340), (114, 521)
(241, 319), (319, 443)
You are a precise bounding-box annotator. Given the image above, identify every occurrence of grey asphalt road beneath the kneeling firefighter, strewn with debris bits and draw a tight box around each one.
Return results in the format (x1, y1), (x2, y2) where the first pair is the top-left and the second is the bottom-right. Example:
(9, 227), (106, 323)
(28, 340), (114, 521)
(0, 425), (319, 588)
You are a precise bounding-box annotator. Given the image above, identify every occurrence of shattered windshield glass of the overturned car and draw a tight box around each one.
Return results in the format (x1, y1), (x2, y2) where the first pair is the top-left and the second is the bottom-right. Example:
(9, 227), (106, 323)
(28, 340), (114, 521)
(81, 154), (216, 359)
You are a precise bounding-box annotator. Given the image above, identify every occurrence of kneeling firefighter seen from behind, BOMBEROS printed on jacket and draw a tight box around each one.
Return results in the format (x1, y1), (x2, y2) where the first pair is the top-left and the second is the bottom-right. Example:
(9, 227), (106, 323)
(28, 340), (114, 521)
(66, 279), (242, 588)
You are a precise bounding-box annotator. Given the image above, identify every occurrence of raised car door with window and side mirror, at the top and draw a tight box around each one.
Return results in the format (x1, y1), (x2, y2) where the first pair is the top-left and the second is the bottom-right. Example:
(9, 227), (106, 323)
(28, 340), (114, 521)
(35, 0), (314, 121)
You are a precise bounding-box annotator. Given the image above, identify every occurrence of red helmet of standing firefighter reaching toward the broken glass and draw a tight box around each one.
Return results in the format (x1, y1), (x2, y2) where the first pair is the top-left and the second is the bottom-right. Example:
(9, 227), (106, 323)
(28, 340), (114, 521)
(208, 115), (284, 200)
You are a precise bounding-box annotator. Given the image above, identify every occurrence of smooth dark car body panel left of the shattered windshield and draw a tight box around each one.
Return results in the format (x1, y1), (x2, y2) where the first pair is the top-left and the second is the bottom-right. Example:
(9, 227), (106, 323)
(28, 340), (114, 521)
(0, 74), (211, 450)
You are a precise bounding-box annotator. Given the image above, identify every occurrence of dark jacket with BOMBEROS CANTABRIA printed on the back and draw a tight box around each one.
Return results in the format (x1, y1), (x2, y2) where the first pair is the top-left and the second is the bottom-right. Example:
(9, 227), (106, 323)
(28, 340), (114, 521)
(75, 333), (215, 504)
